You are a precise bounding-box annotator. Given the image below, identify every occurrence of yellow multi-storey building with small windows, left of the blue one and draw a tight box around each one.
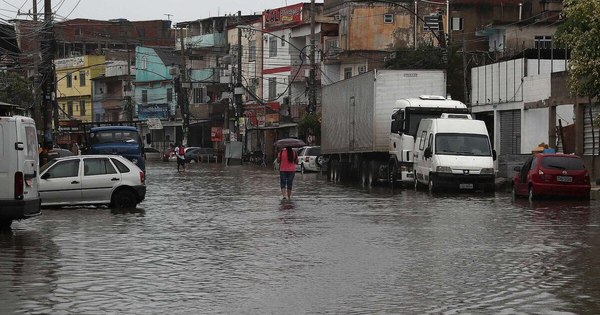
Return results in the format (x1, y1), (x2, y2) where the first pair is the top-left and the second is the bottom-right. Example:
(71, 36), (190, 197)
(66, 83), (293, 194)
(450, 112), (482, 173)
(54, 55), (105, 122)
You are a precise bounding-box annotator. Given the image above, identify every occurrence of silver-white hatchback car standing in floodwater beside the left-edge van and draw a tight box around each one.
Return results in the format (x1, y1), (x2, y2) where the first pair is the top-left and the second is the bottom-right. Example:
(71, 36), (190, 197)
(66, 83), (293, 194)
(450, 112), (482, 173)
(39, 155), (146, 208)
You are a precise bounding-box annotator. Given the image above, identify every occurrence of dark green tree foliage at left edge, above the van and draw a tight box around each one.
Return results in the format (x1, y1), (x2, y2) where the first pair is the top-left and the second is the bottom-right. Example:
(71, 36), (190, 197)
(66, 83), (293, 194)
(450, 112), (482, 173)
(0, 72), (35, 108)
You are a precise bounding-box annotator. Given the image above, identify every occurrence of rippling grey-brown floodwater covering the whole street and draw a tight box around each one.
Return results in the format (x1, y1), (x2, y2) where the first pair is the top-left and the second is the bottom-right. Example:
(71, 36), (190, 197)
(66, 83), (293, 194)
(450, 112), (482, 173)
(0, 162), (600, 314)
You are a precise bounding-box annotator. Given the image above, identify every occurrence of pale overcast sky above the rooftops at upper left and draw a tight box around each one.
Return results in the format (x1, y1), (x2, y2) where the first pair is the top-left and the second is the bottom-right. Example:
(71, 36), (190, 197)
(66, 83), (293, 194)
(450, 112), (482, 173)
(0, 0), (323, 22)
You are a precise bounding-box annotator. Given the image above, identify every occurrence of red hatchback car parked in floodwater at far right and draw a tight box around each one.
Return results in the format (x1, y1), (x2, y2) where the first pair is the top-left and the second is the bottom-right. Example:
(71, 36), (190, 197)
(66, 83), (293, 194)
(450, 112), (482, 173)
(513, 153), (591, 200)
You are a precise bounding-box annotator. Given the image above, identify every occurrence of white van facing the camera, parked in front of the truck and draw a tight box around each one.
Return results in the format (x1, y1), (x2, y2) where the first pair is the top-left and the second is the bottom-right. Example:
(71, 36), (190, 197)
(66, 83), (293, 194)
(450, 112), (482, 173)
(413, 114), (496, 192)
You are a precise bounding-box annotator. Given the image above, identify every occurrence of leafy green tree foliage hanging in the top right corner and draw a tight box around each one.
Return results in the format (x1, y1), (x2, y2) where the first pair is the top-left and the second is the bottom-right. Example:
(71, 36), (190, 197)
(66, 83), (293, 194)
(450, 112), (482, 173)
(556, 0), (600, 98)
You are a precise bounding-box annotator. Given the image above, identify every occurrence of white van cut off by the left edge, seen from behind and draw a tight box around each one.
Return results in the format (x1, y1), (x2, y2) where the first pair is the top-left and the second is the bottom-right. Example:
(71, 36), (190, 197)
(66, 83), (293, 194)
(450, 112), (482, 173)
(0, 116), (41, 228)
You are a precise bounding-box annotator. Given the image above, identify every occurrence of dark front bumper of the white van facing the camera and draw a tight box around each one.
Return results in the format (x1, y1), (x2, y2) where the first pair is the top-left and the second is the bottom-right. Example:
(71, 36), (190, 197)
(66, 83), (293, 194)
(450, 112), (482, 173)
(431, 173), (496, 192)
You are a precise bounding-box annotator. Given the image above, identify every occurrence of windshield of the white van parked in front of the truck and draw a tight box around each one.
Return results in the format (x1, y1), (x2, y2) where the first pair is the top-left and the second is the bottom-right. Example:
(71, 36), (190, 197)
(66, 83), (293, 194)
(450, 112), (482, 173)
(435, 133), (492, 156)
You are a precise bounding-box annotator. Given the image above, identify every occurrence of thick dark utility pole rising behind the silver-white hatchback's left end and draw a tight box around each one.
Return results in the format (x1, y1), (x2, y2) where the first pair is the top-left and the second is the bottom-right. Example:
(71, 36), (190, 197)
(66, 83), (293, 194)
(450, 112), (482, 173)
(39, 0), (55, 146)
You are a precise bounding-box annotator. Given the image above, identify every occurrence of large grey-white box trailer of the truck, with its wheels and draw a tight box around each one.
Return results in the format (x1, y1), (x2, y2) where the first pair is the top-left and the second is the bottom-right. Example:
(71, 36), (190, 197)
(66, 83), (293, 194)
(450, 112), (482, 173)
(321, 70), (446, 184)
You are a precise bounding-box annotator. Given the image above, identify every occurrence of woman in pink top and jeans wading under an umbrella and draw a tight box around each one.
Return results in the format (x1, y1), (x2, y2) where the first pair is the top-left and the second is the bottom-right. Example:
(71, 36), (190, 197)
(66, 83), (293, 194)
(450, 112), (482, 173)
(275, 138), (306, 199)
